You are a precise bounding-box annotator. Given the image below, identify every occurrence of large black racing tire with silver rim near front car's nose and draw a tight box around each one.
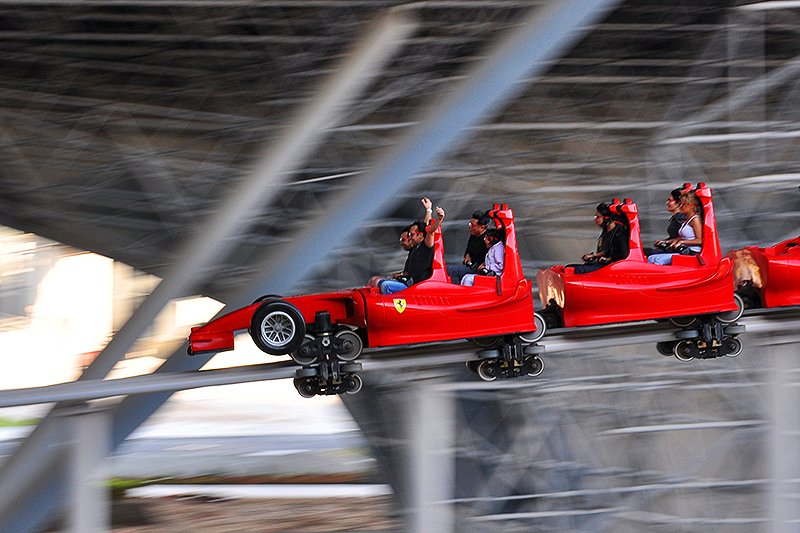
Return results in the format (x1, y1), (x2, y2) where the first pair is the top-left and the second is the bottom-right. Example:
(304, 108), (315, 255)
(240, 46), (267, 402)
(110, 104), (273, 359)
(250, 301), (306, 355)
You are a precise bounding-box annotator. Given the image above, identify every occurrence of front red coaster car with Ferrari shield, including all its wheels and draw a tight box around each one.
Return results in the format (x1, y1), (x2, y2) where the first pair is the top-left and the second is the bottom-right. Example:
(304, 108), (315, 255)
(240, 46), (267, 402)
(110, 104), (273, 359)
(189, 204), (544, 397)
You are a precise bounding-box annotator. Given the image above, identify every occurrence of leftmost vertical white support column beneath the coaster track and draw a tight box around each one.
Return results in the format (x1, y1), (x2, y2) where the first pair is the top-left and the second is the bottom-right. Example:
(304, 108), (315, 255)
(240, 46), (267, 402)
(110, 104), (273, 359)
(60, 407), (111, 533)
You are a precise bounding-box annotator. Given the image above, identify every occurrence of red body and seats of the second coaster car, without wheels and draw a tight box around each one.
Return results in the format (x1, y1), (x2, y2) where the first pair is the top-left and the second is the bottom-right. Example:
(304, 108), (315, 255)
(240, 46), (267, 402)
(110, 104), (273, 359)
(537, 183), (739, 327)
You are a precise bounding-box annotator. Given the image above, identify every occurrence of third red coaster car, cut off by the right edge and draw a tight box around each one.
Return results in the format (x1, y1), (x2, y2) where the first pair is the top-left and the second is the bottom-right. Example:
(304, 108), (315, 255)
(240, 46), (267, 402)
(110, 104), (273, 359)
(727, 236), (800, 309)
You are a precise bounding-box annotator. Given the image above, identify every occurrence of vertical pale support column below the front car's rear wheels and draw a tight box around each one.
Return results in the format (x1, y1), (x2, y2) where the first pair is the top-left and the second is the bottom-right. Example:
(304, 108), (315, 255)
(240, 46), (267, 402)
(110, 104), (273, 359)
(406, 382), (456, 533)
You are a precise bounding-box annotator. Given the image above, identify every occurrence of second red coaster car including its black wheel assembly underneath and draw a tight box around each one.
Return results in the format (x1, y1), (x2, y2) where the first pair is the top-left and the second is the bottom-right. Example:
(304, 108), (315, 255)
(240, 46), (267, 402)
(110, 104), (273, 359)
(537, 183), (744, 361)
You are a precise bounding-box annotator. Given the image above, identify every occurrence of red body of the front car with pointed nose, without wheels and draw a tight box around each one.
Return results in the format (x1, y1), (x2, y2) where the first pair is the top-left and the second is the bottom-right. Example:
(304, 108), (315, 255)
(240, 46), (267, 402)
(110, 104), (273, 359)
(189, 205), (536, 353)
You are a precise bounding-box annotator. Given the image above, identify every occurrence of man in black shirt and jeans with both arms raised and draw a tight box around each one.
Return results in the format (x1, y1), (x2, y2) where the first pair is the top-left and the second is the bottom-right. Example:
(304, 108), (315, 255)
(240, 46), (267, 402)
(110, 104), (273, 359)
(370, 198), (444, 294)
